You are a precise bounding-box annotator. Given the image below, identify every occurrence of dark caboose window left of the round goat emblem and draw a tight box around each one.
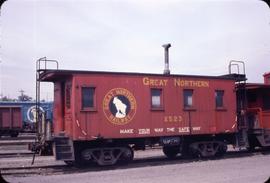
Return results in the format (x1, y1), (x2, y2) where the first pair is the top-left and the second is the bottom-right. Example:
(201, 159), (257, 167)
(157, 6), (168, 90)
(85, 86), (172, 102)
(82, 87), (95, 109)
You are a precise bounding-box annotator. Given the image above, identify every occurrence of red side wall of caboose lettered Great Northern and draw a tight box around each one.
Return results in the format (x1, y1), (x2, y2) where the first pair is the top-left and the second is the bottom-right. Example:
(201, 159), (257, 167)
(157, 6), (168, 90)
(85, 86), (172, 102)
(54, 74), (236, 140)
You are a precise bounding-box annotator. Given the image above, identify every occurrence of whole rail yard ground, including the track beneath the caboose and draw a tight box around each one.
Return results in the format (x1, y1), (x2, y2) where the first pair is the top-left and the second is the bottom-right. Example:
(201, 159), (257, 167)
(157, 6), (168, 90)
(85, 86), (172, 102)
(0, 146), (270, 183)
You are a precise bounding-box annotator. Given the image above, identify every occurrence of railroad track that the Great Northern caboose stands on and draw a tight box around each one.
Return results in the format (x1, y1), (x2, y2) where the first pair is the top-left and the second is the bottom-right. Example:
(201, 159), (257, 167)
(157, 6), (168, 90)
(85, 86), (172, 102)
(0, 151), (270, 176)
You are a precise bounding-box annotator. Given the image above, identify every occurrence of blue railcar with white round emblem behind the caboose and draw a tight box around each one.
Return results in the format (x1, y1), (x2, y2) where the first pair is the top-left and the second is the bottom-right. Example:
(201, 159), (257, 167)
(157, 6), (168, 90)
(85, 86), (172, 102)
(0, 101), (53, 132)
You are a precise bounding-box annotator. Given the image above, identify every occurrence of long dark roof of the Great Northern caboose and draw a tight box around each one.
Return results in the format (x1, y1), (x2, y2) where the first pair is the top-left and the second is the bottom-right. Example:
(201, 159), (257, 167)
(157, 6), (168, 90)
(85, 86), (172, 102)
(38, 69), (246, 81)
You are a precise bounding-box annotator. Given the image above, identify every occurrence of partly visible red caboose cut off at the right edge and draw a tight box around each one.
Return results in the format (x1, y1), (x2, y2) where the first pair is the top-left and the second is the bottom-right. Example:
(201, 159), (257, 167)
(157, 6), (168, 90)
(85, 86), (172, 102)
(245, 73), (270, 149)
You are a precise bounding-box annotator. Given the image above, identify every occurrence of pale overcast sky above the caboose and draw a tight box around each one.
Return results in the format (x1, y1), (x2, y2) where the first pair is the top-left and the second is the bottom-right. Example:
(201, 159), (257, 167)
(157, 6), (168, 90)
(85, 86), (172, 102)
(0, 0), (270, 99)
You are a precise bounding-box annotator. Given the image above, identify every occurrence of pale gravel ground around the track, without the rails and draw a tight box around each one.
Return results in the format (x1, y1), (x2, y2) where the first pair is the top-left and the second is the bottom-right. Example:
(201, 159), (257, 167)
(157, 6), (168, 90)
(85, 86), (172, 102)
(0, 150), (270, 183)
